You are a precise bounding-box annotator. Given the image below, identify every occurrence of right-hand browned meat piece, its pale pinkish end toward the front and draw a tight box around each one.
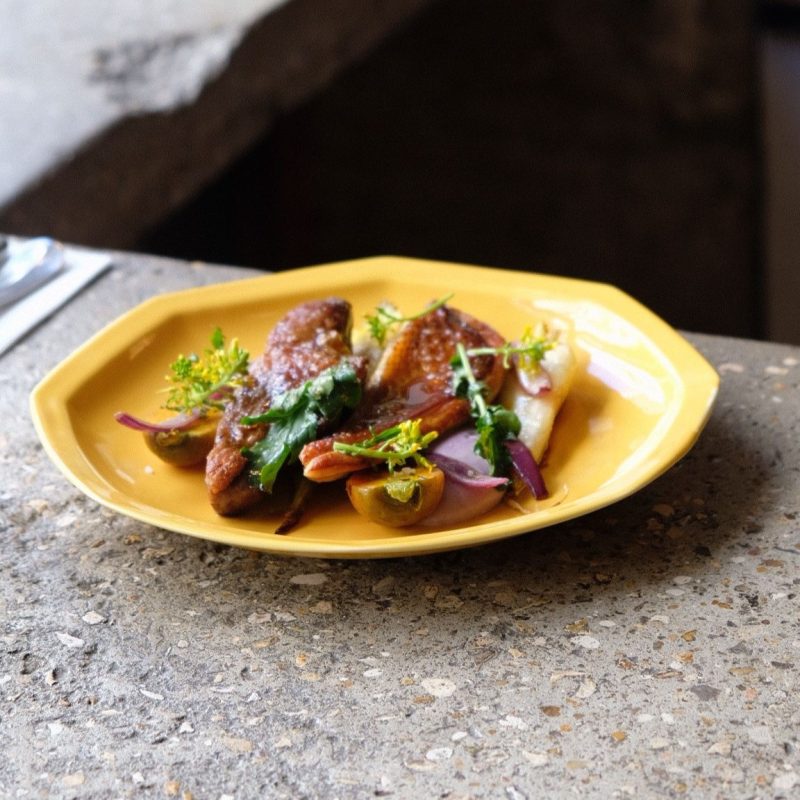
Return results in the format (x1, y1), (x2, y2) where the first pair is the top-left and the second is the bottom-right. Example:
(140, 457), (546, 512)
(300, 306), (504, 482)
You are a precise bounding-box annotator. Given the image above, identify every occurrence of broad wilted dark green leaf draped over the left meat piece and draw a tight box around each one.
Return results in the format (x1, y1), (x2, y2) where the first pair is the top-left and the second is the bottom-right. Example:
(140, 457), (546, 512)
(242, 361), (361, 492)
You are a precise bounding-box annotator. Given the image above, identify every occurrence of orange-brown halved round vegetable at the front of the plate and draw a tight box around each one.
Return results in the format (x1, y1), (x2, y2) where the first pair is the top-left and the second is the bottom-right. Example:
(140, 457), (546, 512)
(347, 467), (444, 528)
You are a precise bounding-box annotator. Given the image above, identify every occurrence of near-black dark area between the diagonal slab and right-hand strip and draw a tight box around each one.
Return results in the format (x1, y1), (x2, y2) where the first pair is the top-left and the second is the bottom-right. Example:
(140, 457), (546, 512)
(139, 0), (764, 336)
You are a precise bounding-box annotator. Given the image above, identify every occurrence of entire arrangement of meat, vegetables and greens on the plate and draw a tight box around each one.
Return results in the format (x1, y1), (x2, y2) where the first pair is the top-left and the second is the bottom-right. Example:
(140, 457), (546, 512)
(115, 297), (576, 533)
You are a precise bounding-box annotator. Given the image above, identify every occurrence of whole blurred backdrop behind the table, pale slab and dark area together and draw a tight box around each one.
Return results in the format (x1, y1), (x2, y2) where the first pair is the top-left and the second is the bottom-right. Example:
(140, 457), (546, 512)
(0, 0), (800, 344)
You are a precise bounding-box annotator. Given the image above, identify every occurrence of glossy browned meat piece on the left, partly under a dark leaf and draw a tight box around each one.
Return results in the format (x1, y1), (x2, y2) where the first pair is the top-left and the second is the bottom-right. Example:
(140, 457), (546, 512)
(206, 297), (363, 516)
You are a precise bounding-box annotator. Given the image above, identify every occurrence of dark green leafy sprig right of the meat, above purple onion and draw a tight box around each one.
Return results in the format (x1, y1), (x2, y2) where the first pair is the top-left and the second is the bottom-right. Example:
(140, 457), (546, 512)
(451, 342), (521, 475)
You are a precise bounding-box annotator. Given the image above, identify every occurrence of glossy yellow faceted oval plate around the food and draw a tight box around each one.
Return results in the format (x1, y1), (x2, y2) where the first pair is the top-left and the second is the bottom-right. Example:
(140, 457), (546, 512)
(31, 257), (718, 558)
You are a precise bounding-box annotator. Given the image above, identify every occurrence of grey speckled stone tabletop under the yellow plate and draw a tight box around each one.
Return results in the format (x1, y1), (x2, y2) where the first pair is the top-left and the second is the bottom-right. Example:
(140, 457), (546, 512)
(0, 247), (800, 800)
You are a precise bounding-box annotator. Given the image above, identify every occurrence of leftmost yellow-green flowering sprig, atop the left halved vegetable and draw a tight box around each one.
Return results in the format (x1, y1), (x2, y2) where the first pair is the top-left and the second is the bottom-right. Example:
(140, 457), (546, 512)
(164, 328), (250, 414)
